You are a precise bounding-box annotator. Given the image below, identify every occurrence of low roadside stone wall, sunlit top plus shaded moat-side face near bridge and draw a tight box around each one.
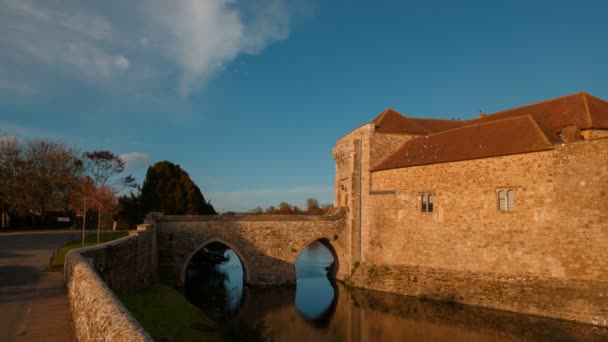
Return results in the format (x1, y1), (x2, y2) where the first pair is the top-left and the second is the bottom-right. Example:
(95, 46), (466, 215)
(64, 225), (158, 341)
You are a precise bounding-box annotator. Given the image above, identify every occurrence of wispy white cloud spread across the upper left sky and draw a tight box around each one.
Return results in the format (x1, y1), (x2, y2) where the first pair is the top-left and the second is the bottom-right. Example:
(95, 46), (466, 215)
(0, 0), (295, 95)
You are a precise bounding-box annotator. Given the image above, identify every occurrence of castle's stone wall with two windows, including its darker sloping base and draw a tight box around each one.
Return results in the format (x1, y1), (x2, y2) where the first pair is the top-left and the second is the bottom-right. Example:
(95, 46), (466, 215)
(346, 139), (608, 325)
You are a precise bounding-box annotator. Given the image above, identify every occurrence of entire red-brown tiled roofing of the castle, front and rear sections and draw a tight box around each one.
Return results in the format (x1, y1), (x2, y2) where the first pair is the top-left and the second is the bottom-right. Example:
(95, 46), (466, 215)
(372, 93), (608, 171)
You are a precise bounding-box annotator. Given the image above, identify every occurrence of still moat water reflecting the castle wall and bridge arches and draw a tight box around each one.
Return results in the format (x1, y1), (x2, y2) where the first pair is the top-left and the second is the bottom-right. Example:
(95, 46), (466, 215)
(186, 243), (608, 342)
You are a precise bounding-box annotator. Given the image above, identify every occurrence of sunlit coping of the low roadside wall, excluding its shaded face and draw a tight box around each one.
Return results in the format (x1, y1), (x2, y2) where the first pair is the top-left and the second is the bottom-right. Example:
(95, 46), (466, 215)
(64, 225), (154, 342)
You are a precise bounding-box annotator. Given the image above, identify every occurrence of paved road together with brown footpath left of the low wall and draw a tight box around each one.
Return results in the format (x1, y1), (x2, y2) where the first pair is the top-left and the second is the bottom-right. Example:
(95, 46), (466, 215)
(0, 232), (78, 342)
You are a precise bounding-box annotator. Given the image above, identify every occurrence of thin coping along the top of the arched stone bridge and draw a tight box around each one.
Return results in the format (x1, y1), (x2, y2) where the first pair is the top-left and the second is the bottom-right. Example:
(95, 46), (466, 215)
(145, 207), (346, 223)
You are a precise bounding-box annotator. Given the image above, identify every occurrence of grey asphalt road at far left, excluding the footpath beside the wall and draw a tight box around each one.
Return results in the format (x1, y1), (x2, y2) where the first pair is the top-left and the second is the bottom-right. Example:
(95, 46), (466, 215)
(0, 232), (78, 341)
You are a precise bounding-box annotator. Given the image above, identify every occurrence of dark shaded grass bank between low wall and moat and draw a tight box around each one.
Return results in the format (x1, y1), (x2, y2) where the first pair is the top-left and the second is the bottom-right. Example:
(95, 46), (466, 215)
(118, 284), (221, 341)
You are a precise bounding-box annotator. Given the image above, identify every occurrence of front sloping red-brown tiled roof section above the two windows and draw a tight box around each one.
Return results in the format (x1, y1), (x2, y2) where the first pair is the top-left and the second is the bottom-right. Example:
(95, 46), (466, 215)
(373, 115), (553, 171)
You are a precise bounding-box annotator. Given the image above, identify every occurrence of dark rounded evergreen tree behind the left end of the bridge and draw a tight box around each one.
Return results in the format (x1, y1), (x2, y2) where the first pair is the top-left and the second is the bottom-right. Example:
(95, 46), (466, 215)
(141, 161), (217, 215)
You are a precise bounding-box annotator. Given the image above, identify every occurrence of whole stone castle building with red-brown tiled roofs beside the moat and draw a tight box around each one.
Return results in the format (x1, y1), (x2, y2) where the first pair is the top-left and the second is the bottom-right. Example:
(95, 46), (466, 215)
(333, 93), (608, 325)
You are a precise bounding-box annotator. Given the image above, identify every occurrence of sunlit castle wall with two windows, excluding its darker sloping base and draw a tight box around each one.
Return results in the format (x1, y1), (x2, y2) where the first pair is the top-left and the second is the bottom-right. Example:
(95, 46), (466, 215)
(363, 139), (608, 281)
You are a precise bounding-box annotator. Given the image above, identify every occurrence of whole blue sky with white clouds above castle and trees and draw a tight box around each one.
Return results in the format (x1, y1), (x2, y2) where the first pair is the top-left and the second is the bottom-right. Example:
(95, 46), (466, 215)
(0, 0), (608, 211)
